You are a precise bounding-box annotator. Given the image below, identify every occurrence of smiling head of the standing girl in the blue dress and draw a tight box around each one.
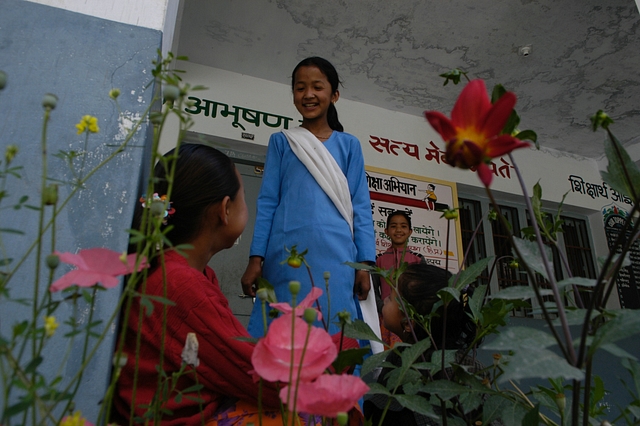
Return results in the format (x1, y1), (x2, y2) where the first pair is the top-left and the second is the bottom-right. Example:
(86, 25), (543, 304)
(291, 56), (344, 132)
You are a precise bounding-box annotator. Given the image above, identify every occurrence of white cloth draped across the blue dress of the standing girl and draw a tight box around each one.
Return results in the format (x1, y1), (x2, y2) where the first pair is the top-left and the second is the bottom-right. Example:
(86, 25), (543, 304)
(282, 127), (384, 353)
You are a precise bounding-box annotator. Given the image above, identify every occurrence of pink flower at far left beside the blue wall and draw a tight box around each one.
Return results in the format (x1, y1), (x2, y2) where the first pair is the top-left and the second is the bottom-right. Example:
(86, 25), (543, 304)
(49, 248), (149, 292)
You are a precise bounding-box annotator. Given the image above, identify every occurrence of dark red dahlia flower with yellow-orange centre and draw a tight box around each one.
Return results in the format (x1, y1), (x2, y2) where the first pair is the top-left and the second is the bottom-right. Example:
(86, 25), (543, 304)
(424, 80), (529, 187)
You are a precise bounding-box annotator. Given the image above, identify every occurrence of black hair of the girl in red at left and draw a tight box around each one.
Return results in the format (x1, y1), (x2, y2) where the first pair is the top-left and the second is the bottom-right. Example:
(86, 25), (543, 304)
(134, 144), (240, 250)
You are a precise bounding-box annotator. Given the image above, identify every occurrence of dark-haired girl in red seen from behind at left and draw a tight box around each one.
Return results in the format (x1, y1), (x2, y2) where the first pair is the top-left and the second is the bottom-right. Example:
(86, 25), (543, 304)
(114, 144), (312, 425)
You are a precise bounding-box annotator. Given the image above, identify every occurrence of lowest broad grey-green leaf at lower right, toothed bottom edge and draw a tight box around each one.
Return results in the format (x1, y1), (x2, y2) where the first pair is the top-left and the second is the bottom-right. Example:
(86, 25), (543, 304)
(498, 347), (584, 383)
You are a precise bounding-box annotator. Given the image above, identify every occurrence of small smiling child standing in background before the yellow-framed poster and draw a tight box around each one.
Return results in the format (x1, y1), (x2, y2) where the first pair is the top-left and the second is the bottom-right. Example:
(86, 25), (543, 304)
(373, 210), (426, 347)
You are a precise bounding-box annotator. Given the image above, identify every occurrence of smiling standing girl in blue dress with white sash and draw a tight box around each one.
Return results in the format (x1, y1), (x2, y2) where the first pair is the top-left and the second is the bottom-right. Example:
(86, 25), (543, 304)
(242, 57), (375, 337)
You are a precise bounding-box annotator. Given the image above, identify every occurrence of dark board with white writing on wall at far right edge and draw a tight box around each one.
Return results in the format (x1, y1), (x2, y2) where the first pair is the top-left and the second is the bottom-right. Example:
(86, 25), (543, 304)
(602, 204), (640, 309)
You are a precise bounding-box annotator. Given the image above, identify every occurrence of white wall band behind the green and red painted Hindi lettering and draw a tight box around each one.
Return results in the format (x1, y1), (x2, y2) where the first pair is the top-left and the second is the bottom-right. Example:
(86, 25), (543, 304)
(161, 62), (611, 214)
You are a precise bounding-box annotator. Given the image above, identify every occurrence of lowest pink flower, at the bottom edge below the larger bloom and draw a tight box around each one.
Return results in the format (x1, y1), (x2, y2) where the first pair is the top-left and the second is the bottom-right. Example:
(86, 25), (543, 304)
(280, 374), (369, 417)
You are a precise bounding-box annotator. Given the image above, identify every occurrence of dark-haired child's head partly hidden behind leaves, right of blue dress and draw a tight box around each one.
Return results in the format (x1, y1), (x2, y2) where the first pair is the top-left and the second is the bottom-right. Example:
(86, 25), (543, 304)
(382, 263), (475, 349)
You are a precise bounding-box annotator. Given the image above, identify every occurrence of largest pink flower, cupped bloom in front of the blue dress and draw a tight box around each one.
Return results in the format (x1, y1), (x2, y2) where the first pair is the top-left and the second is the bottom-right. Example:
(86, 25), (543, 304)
(251, 314), (338, 382)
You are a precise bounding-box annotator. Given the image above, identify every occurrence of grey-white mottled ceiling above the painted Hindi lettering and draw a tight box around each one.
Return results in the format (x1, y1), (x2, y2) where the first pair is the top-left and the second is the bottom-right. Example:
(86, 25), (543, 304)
(174, 0), (640, 160)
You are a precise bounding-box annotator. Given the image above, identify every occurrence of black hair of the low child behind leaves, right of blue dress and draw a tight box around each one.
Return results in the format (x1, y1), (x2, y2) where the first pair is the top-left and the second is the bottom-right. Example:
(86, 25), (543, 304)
(398, 263), (476, 349)
